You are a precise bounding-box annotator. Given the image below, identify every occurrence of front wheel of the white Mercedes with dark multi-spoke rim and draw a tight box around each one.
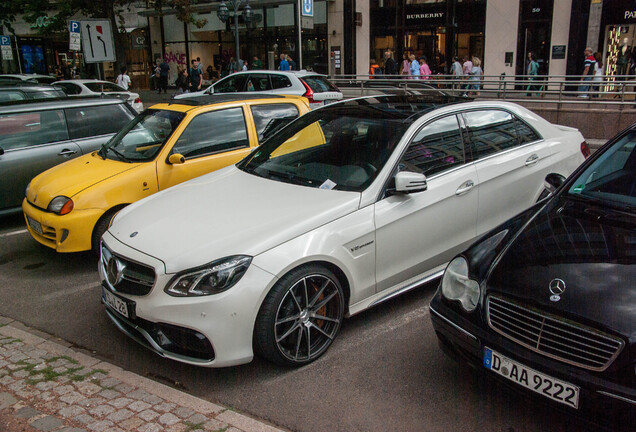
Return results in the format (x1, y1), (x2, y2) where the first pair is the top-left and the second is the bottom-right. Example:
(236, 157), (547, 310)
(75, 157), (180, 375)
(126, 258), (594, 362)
(254, 264), (345, 366)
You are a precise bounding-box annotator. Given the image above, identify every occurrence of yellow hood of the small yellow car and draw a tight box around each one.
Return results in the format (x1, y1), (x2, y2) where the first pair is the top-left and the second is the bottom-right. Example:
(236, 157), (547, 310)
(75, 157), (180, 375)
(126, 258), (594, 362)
(27, 152), (142, 208)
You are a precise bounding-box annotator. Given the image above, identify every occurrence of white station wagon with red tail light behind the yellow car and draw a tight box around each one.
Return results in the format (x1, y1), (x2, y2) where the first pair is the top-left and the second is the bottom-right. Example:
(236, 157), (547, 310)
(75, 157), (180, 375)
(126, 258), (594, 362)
(174, 70), (343, 108)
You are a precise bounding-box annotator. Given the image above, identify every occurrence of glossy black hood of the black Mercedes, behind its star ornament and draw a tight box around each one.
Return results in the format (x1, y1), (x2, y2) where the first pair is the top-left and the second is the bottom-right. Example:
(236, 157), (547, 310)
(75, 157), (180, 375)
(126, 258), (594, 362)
(487, 198), (636, 341)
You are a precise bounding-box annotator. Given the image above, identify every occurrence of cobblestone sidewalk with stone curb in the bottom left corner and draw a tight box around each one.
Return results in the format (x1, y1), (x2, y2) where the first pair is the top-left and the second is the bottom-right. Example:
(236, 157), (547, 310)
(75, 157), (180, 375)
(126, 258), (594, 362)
(0, 317), (282, 432)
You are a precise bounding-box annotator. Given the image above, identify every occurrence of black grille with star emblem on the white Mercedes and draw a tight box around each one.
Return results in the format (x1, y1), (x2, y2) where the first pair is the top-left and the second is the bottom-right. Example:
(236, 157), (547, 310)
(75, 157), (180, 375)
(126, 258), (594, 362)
(101, 244), (155, 295)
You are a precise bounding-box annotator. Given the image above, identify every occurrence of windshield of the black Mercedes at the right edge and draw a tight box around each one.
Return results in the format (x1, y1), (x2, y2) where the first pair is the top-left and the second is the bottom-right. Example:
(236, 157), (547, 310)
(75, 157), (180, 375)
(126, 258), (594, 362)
(568, 132), (636, 208)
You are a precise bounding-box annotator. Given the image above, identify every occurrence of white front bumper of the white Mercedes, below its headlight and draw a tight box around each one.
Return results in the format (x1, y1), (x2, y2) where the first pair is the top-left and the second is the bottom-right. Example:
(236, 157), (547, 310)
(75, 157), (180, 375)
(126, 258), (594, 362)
(98, 232), (275, 367)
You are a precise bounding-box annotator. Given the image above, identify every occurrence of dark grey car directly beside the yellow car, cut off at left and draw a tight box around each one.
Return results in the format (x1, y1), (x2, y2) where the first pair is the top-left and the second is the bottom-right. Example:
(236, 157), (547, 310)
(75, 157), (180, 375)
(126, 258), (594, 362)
(0, 97), (135, 214)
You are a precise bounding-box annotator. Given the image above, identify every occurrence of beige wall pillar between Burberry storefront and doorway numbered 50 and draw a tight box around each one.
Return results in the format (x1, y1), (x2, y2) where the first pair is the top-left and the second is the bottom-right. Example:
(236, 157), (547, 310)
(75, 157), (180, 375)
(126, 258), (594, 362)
(483, 0), (520, 76)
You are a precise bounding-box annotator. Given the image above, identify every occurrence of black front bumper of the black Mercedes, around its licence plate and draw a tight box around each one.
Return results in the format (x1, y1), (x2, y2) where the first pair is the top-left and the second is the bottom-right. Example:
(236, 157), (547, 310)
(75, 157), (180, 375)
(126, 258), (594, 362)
(430, 290), (636, 430)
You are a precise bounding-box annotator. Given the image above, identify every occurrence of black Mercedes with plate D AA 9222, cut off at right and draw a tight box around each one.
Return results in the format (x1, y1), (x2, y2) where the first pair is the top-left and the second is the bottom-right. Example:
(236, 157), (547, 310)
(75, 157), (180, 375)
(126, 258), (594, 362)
(430, 124), (636, 430)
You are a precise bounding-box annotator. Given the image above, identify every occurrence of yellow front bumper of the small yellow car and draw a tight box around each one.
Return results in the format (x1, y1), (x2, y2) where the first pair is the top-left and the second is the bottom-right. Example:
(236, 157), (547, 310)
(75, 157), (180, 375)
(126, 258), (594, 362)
(22, 198), (104, 252)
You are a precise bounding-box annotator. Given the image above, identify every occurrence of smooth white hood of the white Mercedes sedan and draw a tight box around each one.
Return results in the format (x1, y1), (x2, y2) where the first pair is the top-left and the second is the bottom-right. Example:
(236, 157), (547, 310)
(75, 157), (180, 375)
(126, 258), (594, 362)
(109, 166), (360, 273)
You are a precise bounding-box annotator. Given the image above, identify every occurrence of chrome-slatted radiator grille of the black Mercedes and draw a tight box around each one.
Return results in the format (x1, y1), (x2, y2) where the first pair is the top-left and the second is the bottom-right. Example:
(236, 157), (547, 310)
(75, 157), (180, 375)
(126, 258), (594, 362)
(486, 296), (625, 372)
